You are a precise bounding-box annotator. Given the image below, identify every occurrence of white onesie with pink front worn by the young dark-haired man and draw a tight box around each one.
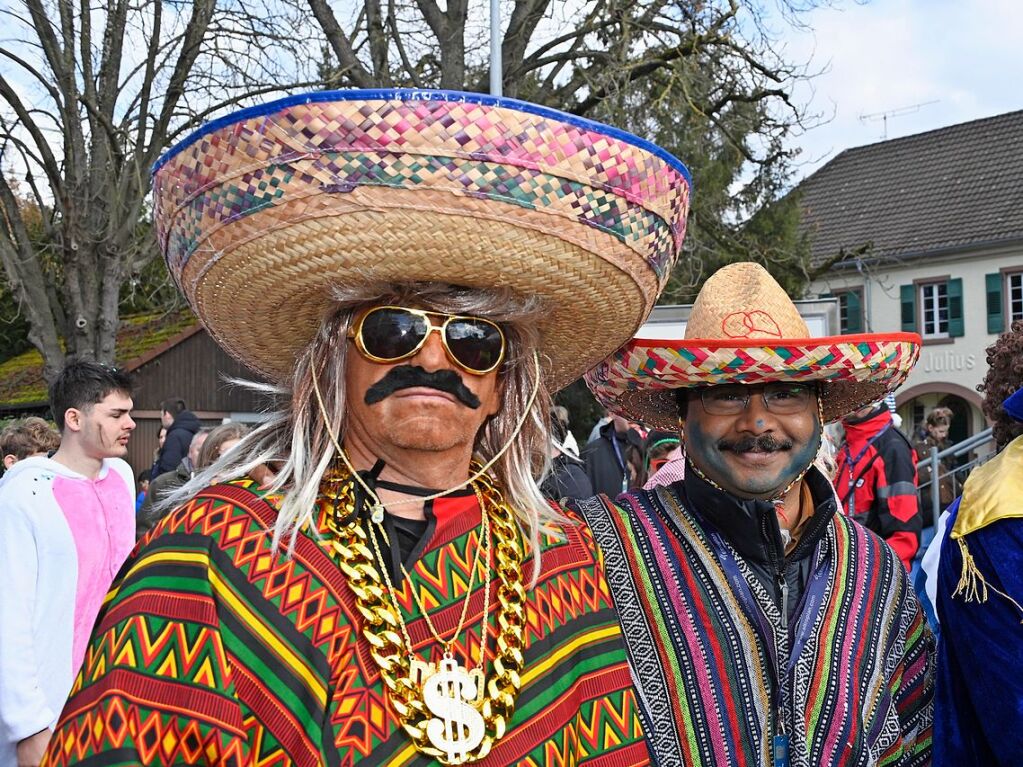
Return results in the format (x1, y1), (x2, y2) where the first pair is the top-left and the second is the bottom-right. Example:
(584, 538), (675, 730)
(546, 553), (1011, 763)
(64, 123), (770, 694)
(0, 457), (135, 767)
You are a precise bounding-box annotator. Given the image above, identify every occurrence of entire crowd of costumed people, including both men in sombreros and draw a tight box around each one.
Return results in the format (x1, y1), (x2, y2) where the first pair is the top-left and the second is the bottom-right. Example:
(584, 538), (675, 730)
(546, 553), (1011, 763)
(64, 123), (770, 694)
(0, 91), (1023, 767)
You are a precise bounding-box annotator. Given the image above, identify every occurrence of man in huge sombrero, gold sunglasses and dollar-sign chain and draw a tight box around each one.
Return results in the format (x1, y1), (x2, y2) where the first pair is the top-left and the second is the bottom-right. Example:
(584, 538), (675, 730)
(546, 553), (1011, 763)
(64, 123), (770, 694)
(43, 91), (690, 767)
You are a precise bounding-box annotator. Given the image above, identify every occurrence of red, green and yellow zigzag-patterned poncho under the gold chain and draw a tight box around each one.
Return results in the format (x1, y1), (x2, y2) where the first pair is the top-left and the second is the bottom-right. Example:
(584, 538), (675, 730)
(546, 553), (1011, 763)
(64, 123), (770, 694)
(41, 481), (650, 767)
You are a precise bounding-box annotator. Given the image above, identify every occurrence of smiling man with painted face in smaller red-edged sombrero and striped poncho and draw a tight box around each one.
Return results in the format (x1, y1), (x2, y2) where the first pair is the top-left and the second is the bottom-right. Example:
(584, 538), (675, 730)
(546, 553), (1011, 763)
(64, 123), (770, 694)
(579, 264), (933, 767)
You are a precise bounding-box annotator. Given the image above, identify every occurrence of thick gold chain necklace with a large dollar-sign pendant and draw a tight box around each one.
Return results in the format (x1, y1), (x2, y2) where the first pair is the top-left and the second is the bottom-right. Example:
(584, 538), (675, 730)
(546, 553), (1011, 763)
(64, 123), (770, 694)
(320, 475), (526, 764)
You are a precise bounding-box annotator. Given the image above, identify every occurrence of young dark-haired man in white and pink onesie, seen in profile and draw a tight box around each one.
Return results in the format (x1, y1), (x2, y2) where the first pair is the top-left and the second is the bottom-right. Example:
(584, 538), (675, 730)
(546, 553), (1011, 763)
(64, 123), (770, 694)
(0, 360), (135, 767)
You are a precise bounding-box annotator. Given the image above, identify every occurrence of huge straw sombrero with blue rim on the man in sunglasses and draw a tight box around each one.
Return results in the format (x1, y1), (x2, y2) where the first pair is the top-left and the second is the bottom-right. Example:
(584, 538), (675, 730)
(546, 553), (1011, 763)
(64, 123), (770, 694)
(153, 90), (691, 388)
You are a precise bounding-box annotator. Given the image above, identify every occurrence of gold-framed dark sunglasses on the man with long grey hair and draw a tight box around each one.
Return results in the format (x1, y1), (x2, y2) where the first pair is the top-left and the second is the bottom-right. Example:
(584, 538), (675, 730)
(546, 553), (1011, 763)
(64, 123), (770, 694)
(348, 306), (504, 375)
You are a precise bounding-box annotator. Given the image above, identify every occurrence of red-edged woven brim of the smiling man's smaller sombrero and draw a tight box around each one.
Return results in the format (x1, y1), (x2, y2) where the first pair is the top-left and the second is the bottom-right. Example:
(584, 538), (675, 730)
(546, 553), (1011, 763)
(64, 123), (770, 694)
(586, 332), (921, 428)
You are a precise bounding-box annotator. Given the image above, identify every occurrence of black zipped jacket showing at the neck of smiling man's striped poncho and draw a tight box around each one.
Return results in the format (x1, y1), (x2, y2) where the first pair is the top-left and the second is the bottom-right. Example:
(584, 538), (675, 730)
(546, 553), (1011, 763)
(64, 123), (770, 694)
(681, 464), (838, 619)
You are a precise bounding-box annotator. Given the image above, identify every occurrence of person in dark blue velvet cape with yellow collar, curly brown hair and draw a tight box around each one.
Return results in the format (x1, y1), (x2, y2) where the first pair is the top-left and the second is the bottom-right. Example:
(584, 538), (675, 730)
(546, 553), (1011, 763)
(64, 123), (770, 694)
(934, 322), (1023, 767)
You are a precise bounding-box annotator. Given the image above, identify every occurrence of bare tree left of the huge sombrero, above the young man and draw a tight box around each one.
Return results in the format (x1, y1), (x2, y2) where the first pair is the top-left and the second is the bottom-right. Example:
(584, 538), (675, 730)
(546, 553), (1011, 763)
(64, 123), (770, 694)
(0, 0), (310, 379)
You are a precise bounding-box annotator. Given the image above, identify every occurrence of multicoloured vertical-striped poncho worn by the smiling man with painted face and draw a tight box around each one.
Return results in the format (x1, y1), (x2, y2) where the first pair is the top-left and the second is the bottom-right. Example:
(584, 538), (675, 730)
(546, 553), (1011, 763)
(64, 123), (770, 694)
(579, 469), (933, 767)
